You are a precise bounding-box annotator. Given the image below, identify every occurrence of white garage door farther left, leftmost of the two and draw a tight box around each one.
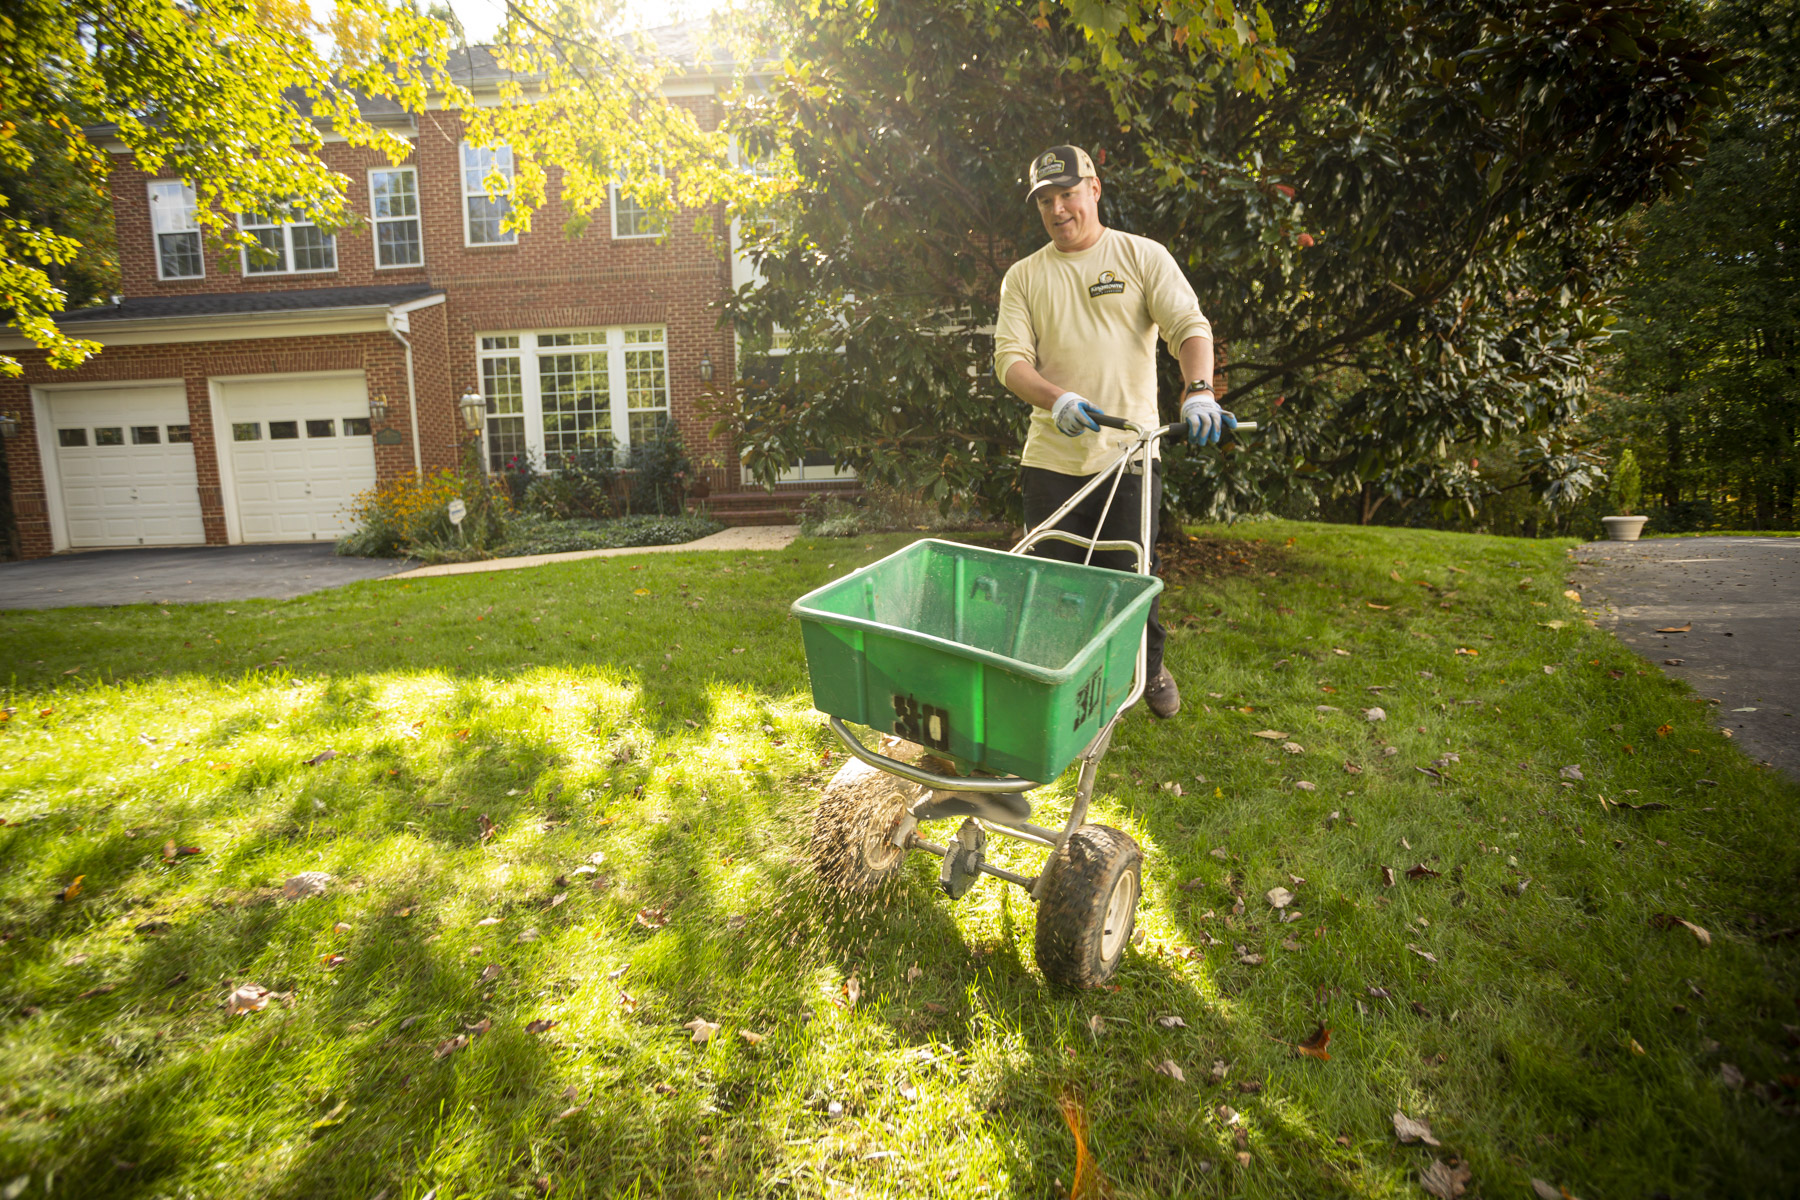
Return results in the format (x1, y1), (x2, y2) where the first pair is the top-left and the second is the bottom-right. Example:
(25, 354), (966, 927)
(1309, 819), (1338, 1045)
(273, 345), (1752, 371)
(47, 383), (207, 547)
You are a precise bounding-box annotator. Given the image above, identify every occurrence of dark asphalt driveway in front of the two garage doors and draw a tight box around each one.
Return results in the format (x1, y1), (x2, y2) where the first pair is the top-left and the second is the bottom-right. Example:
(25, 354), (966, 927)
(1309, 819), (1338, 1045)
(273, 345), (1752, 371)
(0, 542), (412, 608)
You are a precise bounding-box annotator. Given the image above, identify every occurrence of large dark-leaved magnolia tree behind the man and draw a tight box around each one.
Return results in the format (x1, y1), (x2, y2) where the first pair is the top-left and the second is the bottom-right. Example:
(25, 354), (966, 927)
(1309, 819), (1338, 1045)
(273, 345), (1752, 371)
(729, 0), (1724, 520)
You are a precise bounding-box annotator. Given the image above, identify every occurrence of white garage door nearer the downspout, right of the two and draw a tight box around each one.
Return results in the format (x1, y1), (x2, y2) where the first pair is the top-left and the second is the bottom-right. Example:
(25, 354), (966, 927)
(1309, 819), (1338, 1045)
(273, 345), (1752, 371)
(220, 374), (374, 542)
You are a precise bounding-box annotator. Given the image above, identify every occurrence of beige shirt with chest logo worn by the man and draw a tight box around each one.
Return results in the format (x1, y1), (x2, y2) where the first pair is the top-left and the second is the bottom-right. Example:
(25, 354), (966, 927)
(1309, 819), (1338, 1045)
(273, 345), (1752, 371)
(994, 228), (1213, 475)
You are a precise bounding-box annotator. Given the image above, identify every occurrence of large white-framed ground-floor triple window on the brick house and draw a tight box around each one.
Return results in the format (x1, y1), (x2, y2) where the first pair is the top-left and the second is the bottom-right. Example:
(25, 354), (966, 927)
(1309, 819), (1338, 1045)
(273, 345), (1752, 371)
(479, 326), (670, 471)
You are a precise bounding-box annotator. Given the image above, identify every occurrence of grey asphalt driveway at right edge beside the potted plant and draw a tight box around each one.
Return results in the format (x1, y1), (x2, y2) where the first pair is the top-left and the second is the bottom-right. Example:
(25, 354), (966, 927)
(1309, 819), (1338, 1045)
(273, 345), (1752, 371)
(1571, 538), (1800, 779)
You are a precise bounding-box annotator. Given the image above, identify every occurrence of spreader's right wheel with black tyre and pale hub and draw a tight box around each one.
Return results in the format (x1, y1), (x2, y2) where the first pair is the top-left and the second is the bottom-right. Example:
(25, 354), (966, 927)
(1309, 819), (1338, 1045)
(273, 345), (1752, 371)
(1037, 826), (1143, 988)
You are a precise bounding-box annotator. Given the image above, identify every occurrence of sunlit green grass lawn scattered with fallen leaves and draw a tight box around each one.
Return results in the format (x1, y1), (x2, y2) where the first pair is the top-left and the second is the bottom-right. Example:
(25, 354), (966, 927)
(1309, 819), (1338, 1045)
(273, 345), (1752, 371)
(0, 524), (1800, 1200)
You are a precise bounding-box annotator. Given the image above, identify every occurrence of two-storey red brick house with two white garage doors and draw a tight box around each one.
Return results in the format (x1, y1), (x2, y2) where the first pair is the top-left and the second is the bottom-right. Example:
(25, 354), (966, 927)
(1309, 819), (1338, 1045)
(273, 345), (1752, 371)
(0, 37), (828, 558)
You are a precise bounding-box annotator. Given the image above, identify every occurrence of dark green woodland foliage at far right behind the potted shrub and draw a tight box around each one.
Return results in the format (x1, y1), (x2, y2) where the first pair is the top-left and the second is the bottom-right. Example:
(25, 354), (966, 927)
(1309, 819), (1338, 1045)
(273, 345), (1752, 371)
(1607, 0), (1800, 531)
